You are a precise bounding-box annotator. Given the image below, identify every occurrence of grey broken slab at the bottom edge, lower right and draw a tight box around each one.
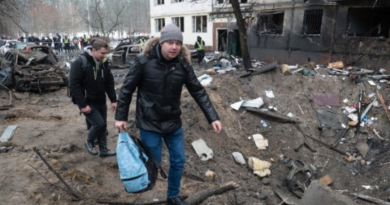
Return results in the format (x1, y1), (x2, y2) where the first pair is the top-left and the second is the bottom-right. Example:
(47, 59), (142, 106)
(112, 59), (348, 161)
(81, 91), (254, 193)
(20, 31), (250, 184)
(299, 180), (356, 205)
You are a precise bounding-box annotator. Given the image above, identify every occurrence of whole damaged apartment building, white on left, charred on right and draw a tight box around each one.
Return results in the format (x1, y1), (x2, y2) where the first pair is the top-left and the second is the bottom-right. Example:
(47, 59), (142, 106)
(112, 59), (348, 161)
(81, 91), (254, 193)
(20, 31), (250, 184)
(150, 0), (390, 66)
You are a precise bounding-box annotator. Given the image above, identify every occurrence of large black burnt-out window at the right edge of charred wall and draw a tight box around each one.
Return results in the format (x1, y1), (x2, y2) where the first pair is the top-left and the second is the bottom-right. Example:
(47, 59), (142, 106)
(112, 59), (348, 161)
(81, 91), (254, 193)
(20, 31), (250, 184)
(346, 8), (390, 38)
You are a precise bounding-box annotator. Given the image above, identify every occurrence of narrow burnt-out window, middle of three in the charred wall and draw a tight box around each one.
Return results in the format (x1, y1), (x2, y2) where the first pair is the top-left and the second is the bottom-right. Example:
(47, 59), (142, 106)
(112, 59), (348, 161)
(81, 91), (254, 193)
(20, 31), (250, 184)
(303, 9), (322, 35)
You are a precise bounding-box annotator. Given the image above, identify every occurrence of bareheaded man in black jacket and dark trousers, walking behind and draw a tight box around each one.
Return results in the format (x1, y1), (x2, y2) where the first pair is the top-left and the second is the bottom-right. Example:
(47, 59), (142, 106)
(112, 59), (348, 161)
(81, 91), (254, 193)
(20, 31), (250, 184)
(70, 39), (117, 157)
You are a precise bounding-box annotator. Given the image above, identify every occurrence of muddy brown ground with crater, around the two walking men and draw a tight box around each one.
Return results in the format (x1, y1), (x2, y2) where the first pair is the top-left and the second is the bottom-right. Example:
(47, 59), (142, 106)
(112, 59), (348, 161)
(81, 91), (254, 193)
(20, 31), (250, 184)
(0, 52), (390, 205)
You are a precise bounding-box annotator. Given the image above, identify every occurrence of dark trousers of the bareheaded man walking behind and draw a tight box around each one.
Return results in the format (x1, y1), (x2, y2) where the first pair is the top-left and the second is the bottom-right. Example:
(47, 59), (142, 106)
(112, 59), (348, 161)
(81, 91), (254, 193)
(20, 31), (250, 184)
(84, 104), (107, 149)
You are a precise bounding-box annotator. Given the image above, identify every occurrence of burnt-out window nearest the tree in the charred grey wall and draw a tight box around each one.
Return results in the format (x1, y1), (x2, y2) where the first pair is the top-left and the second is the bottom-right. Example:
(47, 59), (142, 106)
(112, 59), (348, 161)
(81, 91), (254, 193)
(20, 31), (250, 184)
(258, 12), (284, 34)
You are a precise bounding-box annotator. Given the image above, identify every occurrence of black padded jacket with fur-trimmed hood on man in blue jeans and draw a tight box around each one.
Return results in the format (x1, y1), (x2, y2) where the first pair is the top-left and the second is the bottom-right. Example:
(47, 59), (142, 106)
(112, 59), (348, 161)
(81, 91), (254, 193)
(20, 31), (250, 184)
(115, 40), (219, 134)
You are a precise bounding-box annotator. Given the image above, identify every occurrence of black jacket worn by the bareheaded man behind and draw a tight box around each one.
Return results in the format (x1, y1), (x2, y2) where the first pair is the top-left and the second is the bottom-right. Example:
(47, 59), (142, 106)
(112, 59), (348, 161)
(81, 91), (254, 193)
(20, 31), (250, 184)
(69, 51), (117, 109)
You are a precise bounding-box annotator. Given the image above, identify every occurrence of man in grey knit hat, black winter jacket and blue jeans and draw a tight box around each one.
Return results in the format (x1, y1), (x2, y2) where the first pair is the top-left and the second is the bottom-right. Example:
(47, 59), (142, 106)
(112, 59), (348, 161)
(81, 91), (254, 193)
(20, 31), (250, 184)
(115, 24), (222, 205)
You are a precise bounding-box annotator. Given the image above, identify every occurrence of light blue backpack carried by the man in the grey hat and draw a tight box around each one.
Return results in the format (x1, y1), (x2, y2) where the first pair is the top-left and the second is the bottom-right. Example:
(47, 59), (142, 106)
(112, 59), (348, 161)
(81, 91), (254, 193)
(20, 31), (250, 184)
(116, 132), (167, 193)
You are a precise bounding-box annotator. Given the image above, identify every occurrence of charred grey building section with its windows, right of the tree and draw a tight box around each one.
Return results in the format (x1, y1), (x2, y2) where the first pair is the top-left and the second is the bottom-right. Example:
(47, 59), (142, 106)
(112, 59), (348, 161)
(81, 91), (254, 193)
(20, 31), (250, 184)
(248, 0), (390, 66)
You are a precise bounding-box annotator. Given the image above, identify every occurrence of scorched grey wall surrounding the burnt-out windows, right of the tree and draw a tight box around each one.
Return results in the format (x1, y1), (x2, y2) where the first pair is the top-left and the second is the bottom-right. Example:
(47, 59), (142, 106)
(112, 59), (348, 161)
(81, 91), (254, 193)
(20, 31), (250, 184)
(248, 3), (390, 66)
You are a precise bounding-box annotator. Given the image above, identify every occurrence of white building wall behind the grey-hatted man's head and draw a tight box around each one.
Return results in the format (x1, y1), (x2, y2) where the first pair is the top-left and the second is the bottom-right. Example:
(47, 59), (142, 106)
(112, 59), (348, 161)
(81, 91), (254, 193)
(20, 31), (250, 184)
(150, 0), (213, 46)
